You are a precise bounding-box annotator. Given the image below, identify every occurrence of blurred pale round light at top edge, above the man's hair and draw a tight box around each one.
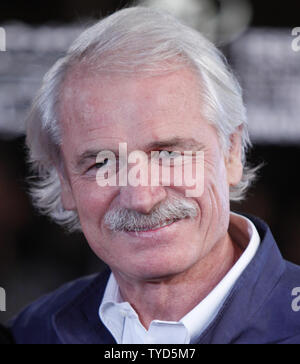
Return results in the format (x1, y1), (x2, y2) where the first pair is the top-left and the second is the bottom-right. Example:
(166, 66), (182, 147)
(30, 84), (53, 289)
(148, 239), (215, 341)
(140, 0), (253, 45)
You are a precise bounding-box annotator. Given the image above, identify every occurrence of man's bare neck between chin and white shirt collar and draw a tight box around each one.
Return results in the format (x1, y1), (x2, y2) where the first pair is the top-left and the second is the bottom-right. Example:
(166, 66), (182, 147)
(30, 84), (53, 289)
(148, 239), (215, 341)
(114, 234), (242, 330)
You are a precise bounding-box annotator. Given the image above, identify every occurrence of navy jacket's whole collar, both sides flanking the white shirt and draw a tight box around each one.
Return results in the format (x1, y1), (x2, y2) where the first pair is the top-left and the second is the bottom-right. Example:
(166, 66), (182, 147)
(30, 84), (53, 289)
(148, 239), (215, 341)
(52, 215), (285, 344)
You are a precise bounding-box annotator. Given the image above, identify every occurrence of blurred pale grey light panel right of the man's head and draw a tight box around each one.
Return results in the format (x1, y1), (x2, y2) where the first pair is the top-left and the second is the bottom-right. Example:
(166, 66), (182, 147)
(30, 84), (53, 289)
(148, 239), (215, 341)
(229, 28), (300, 145)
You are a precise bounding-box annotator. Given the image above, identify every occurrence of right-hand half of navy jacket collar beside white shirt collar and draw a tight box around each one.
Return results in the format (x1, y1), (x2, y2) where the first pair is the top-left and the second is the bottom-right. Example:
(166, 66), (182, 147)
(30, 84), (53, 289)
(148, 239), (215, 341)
(199, 214), (286, 344)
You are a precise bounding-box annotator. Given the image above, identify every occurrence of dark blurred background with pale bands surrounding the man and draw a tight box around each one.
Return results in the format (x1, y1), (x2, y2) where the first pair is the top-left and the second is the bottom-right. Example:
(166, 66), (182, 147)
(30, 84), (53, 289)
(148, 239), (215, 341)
(0, 0), (300, 322)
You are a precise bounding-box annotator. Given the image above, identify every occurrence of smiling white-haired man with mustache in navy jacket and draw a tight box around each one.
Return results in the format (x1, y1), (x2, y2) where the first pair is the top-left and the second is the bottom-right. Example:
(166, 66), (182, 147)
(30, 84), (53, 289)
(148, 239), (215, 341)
(13, 8), (300, 344)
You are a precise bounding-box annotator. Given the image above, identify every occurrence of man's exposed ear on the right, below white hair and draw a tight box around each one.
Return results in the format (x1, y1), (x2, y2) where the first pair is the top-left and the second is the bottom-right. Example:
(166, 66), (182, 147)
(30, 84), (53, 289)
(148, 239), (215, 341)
(225, 128), (243, 186)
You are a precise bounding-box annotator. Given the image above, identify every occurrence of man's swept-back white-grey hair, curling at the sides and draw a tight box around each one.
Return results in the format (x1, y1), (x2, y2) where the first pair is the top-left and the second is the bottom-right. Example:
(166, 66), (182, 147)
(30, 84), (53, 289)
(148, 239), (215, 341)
(27, 7), (256, 231)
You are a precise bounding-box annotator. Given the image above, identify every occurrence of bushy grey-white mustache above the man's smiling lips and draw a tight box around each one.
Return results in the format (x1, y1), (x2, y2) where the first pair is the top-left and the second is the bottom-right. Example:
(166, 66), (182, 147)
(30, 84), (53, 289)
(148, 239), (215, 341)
(104, 198), (198, 232)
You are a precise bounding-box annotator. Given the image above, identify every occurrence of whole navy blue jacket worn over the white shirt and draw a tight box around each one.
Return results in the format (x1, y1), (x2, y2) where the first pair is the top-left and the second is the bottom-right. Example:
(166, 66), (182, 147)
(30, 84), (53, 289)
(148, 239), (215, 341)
(12, 216), (300, 344)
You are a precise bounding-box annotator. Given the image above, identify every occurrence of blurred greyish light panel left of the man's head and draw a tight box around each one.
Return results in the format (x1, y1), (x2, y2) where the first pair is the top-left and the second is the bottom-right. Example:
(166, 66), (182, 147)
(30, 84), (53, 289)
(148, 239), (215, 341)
(0, 23), (83, 139)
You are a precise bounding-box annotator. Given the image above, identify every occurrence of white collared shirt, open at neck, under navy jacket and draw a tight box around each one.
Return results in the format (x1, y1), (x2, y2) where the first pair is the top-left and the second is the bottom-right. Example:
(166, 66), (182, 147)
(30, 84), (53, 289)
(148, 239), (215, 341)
(99, 213), (260, 344)
